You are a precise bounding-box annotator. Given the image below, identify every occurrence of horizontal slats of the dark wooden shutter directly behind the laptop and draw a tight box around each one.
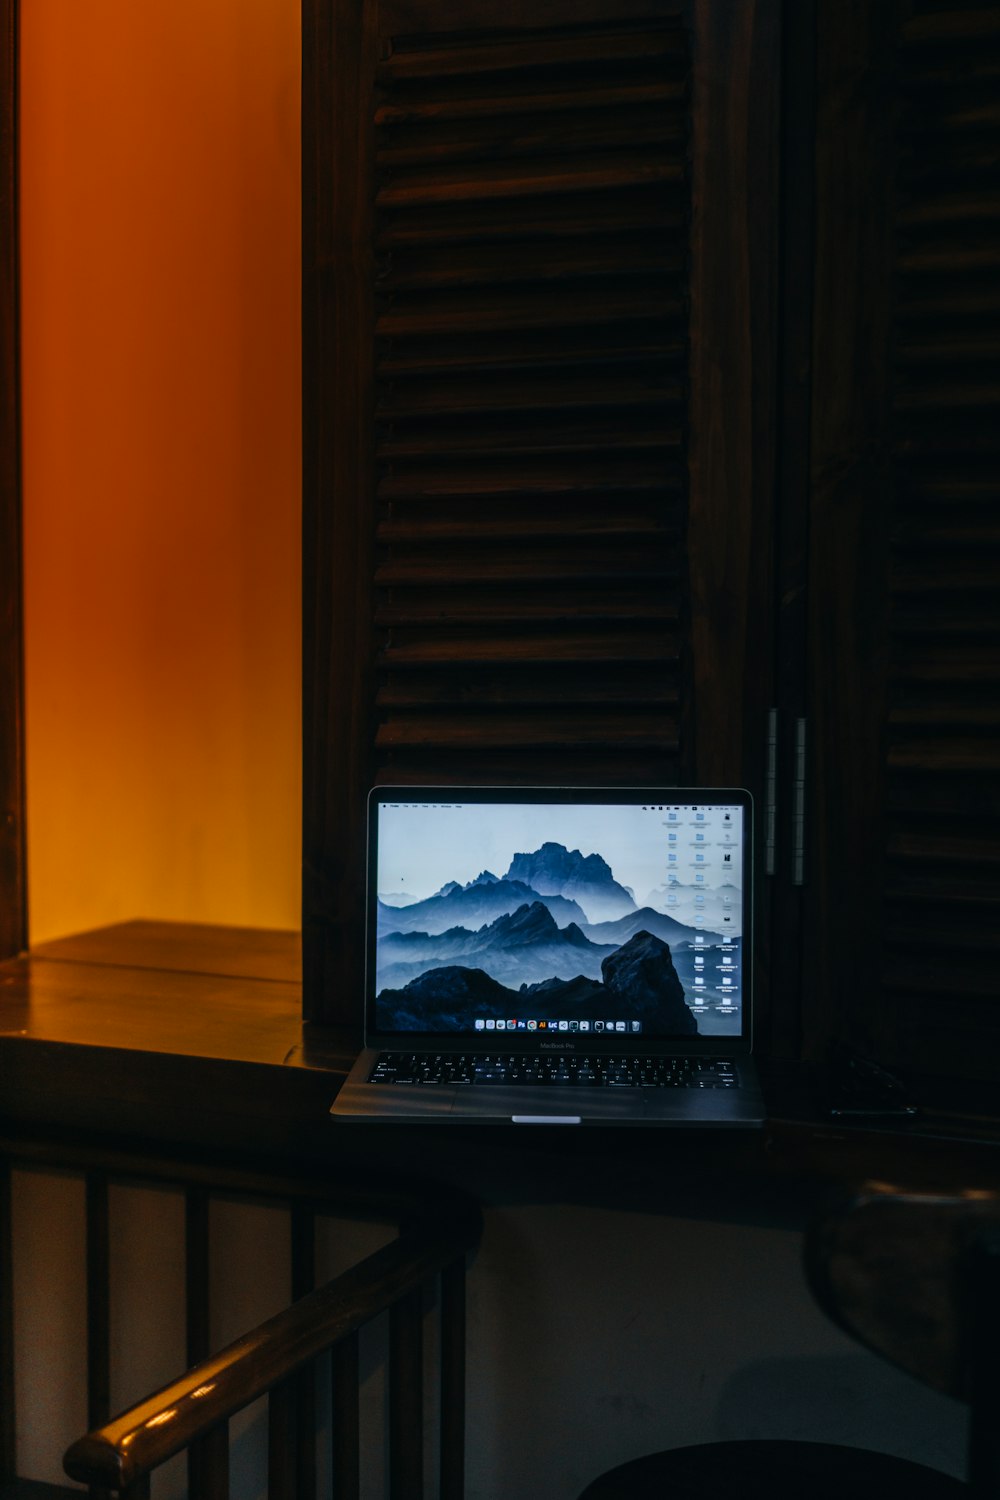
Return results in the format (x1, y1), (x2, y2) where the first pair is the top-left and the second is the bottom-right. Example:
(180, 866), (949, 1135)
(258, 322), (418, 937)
(373, 17), (688, 785)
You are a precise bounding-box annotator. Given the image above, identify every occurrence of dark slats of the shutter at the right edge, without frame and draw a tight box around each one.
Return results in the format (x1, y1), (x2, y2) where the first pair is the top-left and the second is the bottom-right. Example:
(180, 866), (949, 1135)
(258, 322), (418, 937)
(883, 0), (1000, 1080)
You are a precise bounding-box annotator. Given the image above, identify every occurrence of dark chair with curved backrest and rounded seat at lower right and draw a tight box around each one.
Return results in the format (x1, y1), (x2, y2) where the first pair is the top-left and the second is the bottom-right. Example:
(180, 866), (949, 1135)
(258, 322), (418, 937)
(579, 1185), (1000, 1500)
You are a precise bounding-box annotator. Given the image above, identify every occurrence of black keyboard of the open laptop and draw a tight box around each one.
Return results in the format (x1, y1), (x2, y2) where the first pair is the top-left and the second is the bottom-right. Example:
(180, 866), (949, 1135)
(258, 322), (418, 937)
(369, 1052), (736, 1089)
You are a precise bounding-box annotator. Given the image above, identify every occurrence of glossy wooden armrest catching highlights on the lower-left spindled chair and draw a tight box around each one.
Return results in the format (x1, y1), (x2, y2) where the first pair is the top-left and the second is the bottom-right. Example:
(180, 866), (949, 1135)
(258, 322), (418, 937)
(63, 1196), (481, 1490)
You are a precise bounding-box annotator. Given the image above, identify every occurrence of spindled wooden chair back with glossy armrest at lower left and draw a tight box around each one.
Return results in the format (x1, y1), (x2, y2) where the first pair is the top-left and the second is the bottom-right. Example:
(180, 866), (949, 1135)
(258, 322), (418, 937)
(0, 1142), (480, 1500)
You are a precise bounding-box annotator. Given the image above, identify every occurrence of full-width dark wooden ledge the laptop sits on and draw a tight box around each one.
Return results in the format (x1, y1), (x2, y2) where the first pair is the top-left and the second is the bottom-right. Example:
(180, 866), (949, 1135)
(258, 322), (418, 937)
(0, 921), (1000, 1206)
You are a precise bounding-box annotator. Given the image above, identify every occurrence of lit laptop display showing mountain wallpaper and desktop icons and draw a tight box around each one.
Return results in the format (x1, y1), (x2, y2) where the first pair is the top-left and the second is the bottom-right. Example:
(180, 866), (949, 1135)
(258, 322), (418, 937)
(367, 788), (751, 1047)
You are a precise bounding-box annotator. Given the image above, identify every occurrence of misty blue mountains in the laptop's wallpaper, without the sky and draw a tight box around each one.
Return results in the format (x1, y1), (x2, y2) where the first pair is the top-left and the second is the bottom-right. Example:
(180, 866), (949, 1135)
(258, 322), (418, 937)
(375, 842), (741, 1037)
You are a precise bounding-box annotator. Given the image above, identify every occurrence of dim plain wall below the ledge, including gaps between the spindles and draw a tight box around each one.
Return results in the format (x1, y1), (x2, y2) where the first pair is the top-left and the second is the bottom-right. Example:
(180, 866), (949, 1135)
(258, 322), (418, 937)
(13, 1157), (966, 1500)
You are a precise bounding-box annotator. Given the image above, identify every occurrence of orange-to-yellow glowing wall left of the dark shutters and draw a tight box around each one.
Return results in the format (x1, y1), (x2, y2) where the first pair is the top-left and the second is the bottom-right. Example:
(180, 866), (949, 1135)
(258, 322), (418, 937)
(21, 0), (301, 942)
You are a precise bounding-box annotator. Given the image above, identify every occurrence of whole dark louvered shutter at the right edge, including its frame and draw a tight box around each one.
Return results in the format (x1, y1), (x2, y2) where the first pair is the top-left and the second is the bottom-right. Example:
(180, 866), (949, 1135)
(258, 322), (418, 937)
(804, 0), (1000, 1103)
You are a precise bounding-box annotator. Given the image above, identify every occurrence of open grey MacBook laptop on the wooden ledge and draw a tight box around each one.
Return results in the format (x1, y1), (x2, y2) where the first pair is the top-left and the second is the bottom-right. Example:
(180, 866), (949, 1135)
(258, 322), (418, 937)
(331, 786), (765, 1127)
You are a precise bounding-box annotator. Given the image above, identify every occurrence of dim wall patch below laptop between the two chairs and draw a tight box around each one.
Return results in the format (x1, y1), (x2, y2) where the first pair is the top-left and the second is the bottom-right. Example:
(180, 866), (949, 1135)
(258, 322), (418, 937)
(466, 1200), (966, 1500)
